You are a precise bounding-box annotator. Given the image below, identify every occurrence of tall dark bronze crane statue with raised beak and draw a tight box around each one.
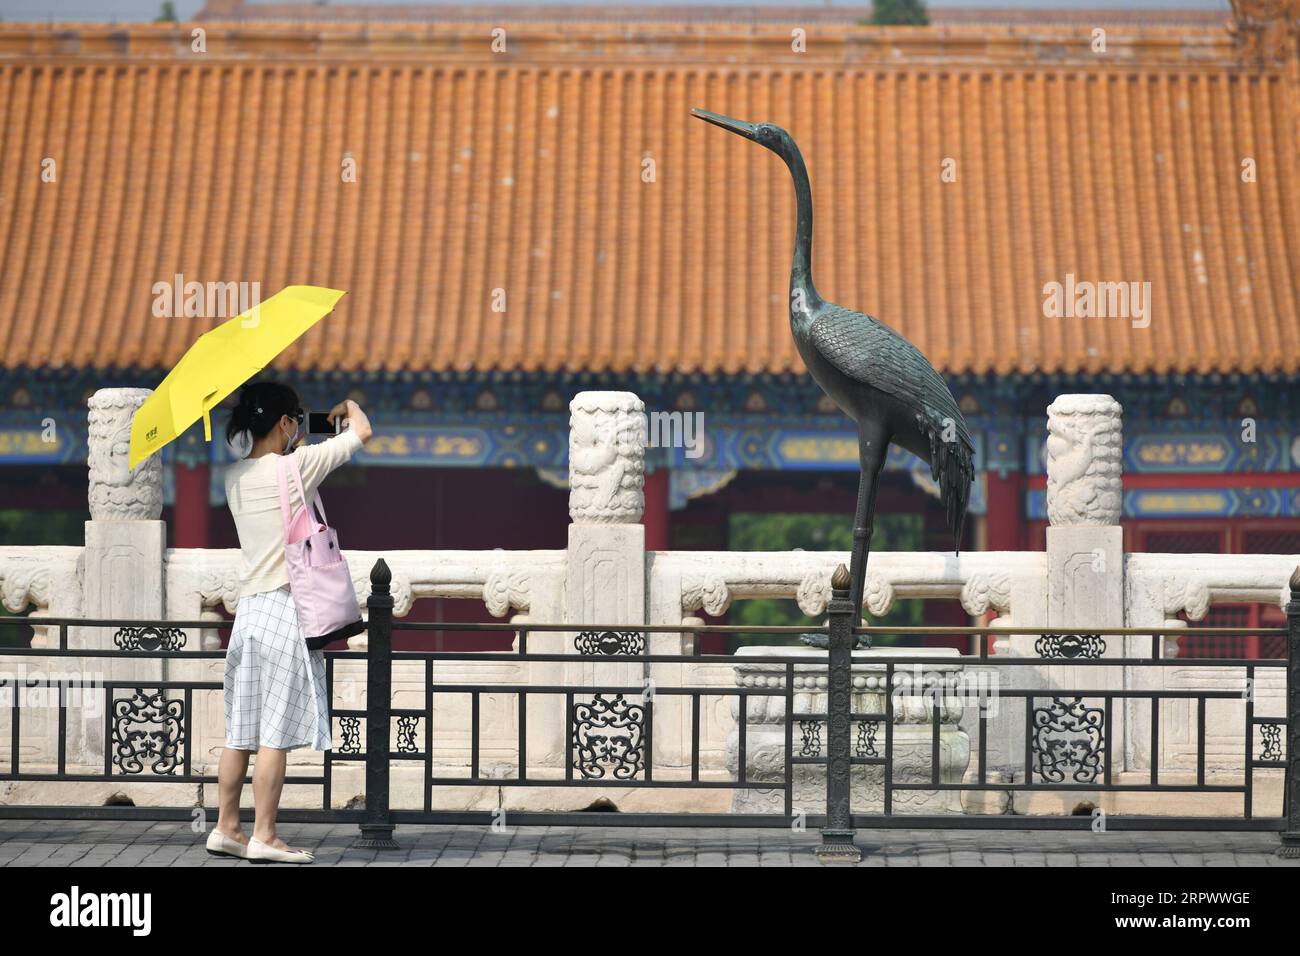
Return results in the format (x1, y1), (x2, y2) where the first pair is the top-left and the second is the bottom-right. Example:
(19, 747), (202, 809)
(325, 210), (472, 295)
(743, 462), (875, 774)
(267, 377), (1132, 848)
(690, 109), (975, 632)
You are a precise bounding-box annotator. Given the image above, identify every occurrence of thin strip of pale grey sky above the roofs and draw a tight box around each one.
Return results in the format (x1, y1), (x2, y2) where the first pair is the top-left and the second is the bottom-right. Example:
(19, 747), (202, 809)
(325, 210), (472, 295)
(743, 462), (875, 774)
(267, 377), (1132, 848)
(0, 0), (1229, 21)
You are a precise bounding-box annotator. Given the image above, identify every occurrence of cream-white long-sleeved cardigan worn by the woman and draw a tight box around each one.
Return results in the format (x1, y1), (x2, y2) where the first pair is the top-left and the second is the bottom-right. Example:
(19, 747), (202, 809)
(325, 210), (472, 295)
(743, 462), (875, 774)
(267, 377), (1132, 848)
(226, 429), (361, 597)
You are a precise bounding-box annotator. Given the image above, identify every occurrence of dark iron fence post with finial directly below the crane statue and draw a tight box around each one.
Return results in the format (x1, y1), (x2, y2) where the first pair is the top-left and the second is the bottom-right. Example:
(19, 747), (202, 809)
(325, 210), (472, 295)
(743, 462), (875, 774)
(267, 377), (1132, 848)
(814, 564), (862, 864)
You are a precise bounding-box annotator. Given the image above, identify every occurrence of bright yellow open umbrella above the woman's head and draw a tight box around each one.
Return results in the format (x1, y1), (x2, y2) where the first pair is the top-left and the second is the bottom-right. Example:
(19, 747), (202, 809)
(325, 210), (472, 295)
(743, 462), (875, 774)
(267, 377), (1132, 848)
(127, 285), (347, 468)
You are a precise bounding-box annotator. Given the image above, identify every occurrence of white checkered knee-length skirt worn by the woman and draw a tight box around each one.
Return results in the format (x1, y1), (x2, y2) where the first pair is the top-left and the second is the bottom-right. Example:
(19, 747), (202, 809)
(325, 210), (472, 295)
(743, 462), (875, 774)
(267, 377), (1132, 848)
(225, 585), (333, 750)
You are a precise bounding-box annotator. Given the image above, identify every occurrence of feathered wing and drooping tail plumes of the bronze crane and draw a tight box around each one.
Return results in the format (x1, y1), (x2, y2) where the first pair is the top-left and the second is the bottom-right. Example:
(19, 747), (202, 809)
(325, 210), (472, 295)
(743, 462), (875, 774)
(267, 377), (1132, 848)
(809, 303), (975, 548)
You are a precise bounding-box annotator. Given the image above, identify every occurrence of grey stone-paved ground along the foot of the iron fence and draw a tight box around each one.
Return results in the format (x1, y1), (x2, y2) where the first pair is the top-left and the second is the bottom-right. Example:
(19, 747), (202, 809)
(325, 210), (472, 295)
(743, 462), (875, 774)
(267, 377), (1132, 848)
(0, 819), (1300, 866)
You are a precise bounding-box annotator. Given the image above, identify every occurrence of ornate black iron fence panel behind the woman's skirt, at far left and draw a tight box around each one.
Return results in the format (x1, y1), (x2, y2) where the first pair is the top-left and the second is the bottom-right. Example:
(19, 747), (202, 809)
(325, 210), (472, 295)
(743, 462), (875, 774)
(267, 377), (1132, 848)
(0, 618), (353, 822)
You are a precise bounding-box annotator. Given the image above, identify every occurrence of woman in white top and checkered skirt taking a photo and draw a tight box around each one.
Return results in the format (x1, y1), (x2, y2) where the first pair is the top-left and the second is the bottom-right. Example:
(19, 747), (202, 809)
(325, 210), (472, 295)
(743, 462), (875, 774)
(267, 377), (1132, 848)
(208, 382), (371, 864)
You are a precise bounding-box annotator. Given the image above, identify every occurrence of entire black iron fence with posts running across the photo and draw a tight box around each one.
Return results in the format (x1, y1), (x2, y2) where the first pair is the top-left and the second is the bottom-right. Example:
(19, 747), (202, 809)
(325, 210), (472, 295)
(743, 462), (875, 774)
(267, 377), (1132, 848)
(0, 561), (1300, 858)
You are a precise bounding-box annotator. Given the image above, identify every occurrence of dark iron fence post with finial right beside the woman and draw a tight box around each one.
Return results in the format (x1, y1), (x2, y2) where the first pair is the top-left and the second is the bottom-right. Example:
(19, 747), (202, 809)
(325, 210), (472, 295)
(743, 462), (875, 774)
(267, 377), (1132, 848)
(352, 558), (398, 849)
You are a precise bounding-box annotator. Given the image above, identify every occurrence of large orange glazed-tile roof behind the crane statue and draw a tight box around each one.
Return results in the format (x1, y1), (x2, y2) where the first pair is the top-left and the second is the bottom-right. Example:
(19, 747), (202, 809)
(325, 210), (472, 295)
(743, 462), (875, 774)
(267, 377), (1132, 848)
(0, 23), (1300, 373)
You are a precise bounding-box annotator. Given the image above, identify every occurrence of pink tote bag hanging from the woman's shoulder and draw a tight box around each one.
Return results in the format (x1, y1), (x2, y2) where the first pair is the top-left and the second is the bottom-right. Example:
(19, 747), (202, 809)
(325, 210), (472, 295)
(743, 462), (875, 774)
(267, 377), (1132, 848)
(276, 455), (365, 650)
